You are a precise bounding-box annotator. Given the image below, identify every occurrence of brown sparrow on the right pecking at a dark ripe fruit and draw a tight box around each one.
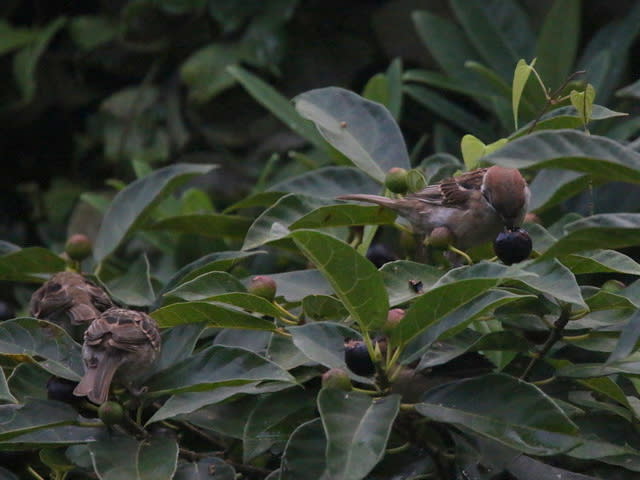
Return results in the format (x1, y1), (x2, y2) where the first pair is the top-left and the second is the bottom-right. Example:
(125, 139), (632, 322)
(338, 165), (530, 250)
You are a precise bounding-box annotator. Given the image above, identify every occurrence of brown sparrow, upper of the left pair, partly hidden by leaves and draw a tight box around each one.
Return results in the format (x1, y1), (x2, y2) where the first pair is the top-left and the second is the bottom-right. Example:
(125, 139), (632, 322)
(29, 272), (113, 333)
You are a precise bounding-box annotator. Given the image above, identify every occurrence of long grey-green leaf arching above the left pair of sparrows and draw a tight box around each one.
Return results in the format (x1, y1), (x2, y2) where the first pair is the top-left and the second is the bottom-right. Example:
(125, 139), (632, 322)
(93, 163), (214, 262)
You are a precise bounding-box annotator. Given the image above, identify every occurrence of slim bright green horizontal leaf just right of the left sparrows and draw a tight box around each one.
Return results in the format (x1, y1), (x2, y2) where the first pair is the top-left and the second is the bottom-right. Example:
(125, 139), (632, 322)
(151, 302), (276, 331)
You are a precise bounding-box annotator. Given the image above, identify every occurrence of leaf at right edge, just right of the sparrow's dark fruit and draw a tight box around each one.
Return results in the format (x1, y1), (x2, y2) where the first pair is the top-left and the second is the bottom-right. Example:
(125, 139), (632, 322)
(543, 213), (640, 258)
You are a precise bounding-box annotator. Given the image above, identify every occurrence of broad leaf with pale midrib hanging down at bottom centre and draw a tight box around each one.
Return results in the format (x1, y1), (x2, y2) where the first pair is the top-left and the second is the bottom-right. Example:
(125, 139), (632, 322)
(318, 389), (400, 480)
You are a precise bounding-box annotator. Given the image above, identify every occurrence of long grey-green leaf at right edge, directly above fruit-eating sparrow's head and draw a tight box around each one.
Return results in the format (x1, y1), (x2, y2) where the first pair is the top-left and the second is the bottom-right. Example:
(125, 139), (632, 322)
(485, 130), (640, 183)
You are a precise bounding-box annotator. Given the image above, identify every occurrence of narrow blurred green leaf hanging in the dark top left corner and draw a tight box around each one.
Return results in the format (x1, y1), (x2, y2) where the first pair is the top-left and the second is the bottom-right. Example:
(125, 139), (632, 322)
(13, 17), (67, 103)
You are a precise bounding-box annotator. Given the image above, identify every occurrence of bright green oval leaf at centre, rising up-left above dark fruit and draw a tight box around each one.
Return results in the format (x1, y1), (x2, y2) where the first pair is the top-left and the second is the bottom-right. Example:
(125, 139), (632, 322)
(290, 230), (389, 332)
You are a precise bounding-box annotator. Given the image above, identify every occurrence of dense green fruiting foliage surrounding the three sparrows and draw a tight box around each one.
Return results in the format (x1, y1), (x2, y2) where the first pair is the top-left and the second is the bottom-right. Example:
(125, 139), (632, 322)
(0, 0), (640, 480)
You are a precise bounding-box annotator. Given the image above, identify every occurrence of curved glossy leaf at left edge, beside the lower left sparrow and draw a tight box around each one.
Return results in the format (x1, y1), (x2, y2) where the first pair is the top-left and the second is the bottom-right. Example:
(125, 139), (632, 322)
(0, 318), (84, 380)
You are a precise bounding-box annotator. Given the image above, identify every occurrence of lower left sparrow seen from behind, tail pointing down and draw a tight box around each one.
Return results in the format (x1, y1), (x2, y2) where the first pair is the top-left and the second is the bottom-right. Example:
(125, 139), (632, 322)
(73, 307), (161, 405)
